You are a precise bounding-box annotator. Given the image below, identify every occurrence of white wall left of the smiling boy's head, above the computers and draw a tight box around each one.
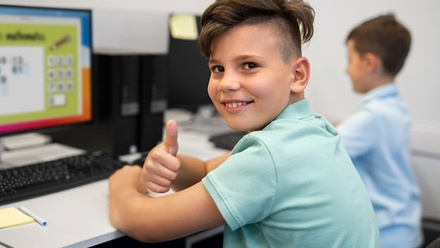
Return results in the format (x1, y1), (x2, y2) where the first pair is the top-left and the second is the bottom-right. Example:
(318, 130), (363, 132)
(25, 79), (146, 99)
(0, 0), (211, 54)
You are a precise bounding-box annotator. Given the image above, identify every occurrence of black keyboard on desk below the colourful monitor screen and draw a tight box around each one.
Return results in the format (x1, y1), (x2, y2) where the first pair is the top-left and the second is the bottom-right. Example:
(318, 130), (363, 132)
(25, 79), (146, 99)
(0, 152), (125, 204)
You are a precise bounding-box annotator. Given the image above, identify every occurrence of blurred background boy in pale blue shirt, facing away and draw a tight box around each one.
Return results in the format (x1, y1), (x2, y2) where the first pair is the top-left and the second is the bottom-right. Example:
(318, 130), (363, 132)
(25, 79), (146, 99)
(338, 14), (422, 248)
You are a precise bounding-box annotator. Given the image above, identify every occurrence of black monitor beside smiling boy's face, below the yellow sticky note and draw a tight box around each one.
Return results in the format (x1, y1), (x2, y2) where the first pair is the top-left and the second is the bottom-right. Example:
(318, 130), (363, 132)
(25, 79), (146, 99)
(167, 16), (212, 111)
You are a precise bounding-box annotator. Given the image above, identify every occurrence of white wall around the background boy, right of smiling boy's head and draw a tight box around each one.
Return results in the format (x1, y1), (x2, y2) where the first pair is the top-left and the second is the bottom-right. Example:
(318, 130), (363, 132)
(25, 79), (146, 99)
(304, 0), (440, 219)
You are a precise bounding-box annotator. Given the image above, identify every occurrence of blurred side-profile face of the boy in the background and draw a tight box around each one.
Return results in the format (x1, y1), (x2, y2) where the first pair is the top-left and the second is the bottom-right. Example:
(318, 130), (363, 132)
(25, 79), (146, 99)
(347, 40), (369, 93)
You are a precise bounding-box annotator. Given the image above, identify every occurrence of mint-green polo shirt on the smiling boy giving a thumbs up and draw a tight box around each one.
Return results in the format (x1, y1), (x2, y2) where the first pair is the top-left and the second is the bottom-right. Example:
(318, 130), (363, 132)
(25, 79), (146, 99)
(202, 100), (379, 248)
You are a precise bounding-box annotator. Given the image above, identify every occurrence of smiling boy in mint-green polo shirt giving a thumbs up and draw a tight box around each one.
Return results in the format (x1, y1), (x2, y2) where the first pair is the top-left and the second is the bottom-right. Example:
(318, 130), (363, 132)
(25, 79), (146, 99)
(109, 0), (379, 248)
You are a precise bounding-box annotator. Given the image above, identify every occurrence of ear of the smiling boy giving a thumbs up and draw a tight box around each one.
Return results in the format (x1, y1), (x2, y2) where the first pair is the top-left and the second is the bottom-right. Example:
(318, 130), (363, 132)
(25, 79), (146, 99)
(290, 57), (310, 93)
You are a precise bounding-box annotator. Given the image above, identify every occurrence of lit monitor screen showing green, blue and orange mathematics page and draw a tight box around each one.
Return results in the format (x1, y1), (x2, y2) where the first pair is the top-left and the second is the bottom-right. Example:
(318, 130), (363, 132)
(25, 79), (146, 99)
(0, 4), (92, 135)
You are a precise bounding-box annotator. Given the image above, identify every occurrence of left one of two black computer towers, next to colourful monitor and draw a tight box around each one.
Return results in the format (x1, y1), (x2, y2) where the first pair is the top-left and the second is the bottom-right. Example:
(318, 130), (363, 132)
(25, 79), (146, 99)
(93, 55), (140, 155)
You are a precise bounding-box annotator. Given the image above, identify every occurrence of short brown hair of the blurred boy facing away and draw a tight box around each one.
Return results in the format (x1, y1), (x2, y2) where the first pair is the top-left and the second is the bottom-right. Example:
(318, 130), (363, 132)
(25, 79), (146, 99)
(346, 14), (411, 77)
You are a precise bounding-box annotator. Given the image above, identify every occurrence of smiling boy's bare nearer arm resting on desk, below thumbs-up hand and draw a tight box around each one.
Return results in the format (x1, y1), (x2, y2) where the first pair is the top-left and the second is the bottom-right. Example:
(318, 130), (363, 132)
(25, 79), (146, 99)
(110, 181), (224, 243)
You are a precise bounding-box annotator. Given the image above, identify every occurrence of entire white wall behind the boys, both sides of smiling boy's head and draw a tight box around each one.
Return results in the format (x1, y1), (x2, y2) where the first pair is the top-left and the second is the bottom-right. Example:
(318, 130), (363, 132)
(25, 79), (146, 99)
(0, 0), (440, 219)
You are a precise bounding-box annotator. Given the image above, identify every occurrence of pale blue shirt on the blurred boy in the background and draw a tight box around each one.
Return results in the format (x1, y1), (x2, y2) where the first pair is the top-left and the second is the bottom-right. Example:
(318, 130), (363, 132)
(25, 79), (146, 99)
(338, 83), (422, 248)
